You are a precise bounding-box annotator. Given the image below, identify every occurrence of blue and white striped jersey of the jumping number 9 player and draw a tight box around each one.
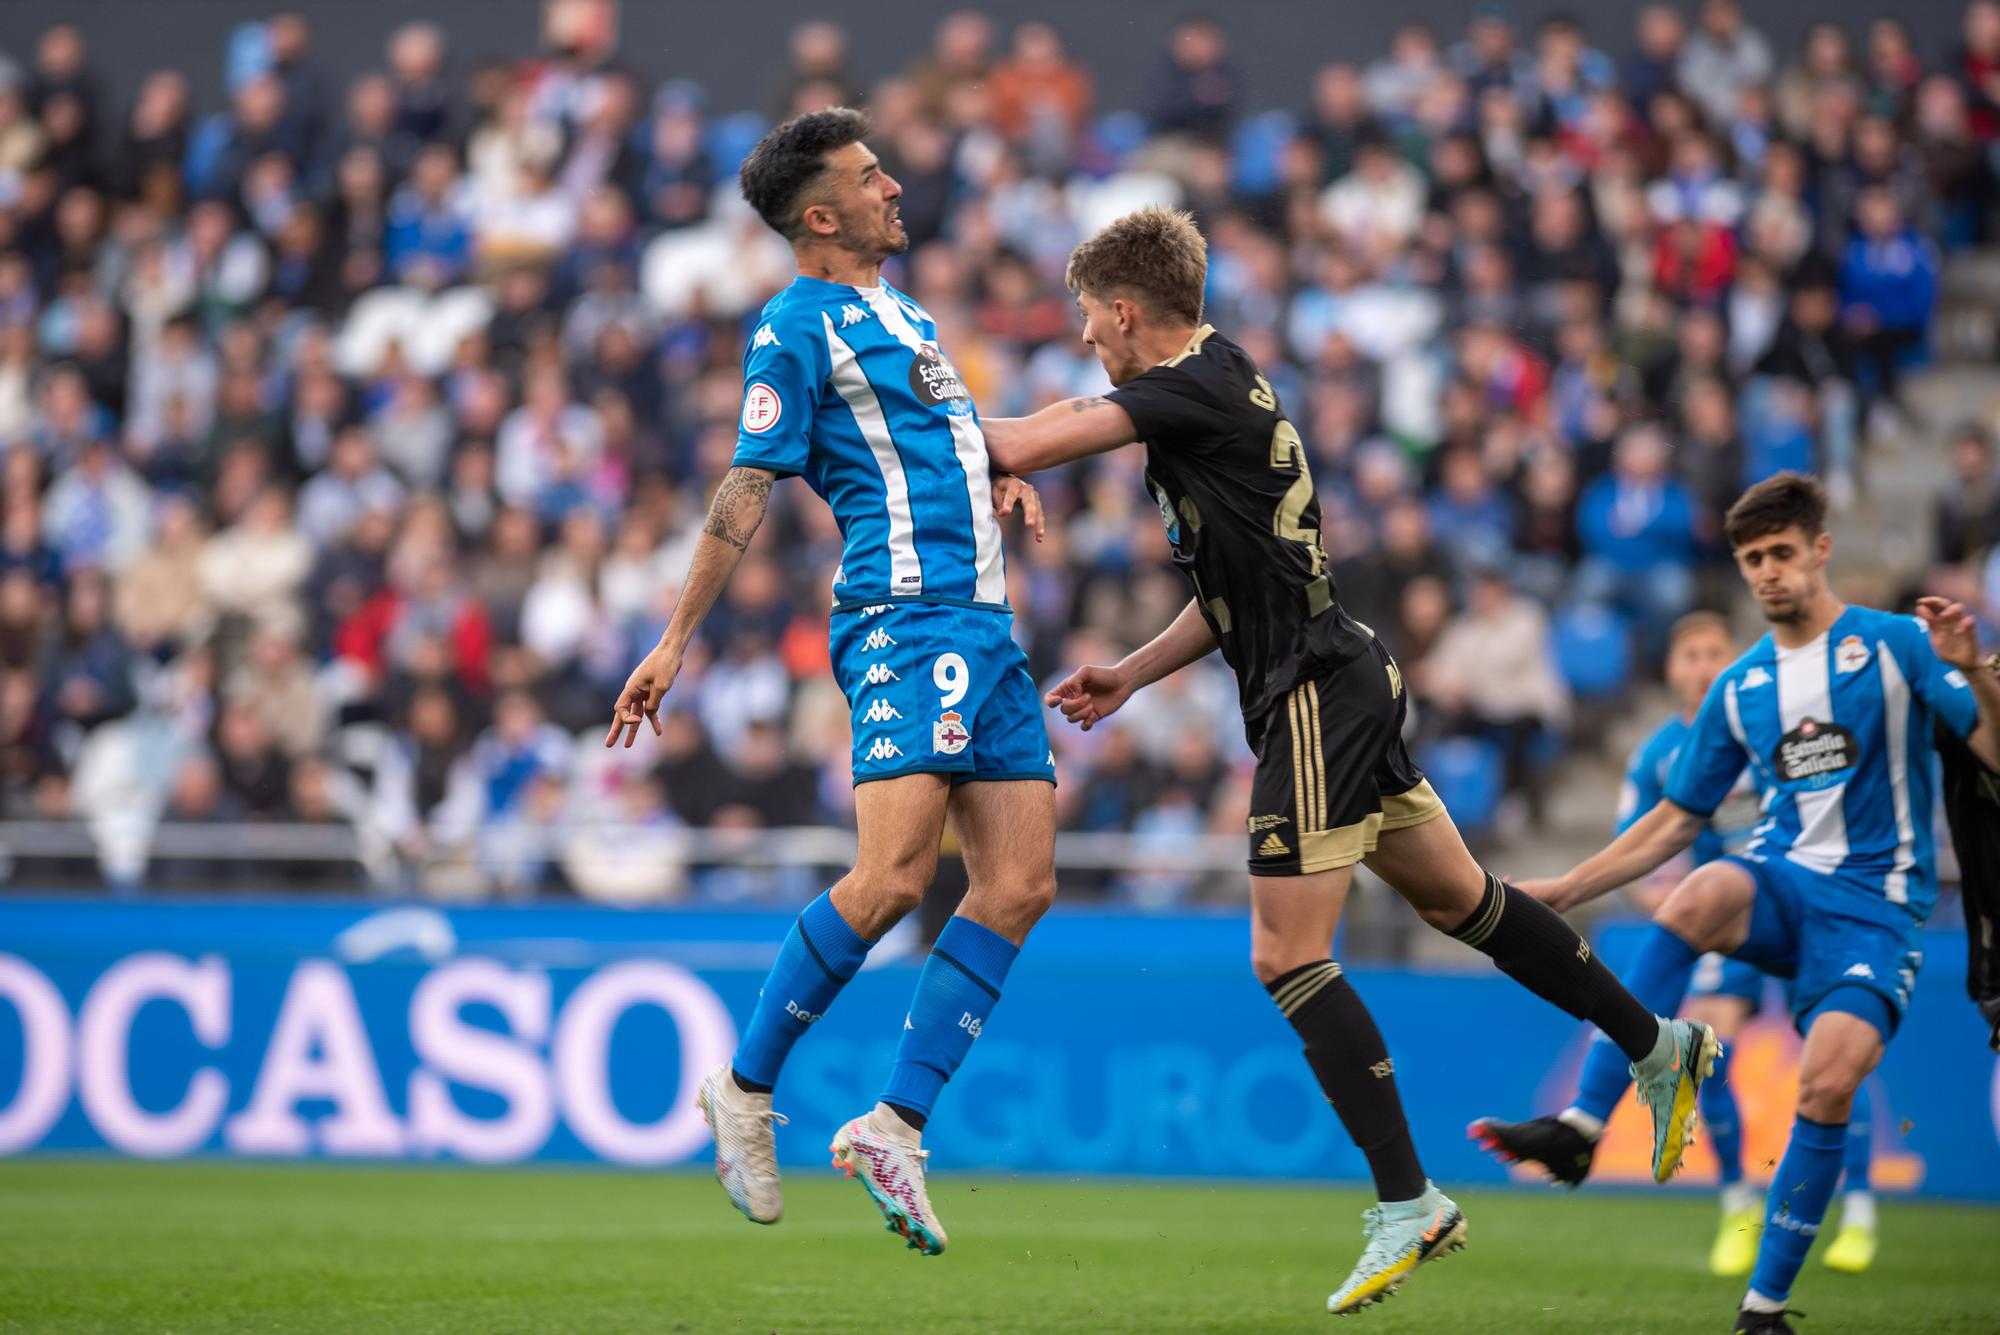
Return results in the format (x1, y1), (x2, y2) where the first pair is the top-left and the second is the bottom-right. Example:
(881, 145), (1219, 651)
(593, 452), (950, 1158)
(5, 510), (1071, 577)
(736, 276), (1006, 612)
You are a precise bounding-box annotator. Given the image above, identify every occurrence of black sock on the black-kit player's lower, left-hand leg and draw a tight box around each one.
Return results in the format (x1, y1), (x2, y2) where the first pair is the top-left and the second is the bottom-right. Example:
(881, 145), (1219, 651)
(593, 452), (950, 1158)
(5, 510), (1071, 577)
(1266, 959), (1424, 1201)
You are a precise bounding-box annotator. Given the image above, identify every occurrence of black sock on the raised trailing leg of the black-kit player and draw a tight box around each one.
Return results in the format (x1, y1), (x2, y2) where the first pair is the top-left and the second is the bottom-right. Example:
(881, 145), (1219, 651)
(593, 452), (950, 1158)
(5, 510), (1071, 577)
(1448, 871), (1660, 1061)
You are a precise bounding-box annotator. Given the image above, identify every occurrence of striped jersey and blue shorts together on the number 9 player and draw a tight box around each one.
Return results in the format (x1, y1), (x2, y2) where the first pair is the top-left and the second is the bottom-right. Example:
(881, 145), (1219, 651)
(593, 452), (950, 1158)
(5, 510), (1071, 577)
(734, 274), (1054, 781)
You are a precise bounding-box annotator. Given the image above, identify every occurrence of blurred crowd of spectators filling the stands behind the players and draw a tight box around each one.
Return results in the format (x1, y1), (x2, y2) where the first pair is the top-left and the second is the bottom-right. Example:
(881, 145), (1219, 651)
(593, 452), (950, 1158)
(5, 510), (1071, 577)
(0, 0), (2000, 901)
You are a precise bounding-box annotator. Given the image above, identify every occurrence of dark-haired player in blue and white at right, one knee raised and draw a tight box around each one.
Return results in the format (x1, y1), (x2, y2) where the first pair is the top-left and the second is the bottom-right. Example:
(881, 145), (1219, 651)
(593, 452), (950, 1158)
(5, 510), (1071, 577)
(1464, 474), (2000, 1335)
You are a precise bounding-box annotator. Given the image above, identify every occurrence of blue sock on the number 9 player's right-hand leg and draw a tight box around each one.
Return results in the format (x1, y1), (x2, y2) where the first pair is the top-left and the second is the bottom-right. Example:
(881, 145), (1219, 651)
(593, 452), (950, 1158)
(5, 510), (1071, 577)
(882, 913), (1020, 1117)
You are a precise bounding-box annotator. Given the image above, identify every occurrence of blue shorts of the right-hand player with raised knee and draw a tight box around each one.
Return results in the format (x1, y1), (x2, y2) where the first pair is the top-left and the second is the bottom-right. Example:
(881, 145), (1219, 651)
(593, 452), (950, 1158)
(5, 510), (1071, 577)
(1726, 853), (1924, 1039)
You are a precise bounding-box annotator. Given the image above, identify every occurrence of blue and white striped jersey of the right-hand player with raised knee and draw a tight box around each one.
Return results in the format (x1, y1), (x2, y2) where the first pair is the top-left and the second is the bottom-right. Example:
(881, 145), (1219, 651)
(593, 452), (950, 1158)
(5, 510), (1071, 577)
(1666, 608), (1978, 919)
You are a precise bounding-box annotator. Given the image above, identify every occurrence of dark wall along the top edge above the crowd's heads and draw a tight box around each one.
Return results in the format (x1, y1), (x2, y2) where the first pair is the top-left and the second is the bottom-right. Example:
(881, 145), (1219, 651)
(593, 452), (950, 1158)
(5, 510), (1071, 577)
(0, 0), (1964, 121)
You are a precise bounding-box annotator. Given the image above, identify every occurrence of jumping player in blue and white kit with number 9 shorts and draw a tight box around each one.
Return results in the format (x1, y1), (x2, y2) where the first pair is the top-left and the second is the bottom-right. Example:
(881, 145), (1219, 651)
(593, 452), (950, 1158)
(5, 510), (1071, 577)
(604, 110), (1056, 1255)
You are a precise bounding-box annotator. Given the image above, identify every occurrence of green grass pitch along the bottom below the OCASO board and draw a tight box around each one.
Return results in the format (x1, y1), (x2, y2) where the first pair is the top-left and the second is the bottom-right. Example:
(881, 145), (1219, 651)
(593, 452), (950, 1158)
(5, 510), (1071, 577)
(0, 1159), (2000, 1335)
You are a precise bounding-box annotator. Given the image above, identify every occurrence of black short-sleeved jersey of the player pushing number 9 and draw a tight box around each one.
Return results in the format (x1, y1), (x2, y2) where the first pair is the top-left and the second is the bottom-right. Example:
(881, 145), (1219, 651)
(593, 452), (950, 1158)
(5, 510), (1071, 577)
(1110, 324), (1372, 727)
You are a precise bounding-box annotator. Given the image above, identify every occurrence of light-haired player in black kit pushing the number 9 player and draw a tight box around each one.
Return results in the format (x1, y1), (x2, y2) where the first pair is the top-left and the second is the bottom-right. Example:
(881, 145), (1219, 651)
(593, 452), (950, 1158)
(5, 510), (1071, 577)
(984, 208), (1714, 1313)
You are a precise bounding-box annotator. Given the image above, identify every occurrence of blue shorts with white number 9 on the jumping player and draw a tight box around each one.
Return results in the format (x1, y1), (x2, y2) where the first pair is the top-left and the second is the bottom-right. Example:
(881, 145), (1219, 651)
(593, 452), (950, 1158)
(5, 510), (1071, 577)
(830, 602), (1056, 783)
